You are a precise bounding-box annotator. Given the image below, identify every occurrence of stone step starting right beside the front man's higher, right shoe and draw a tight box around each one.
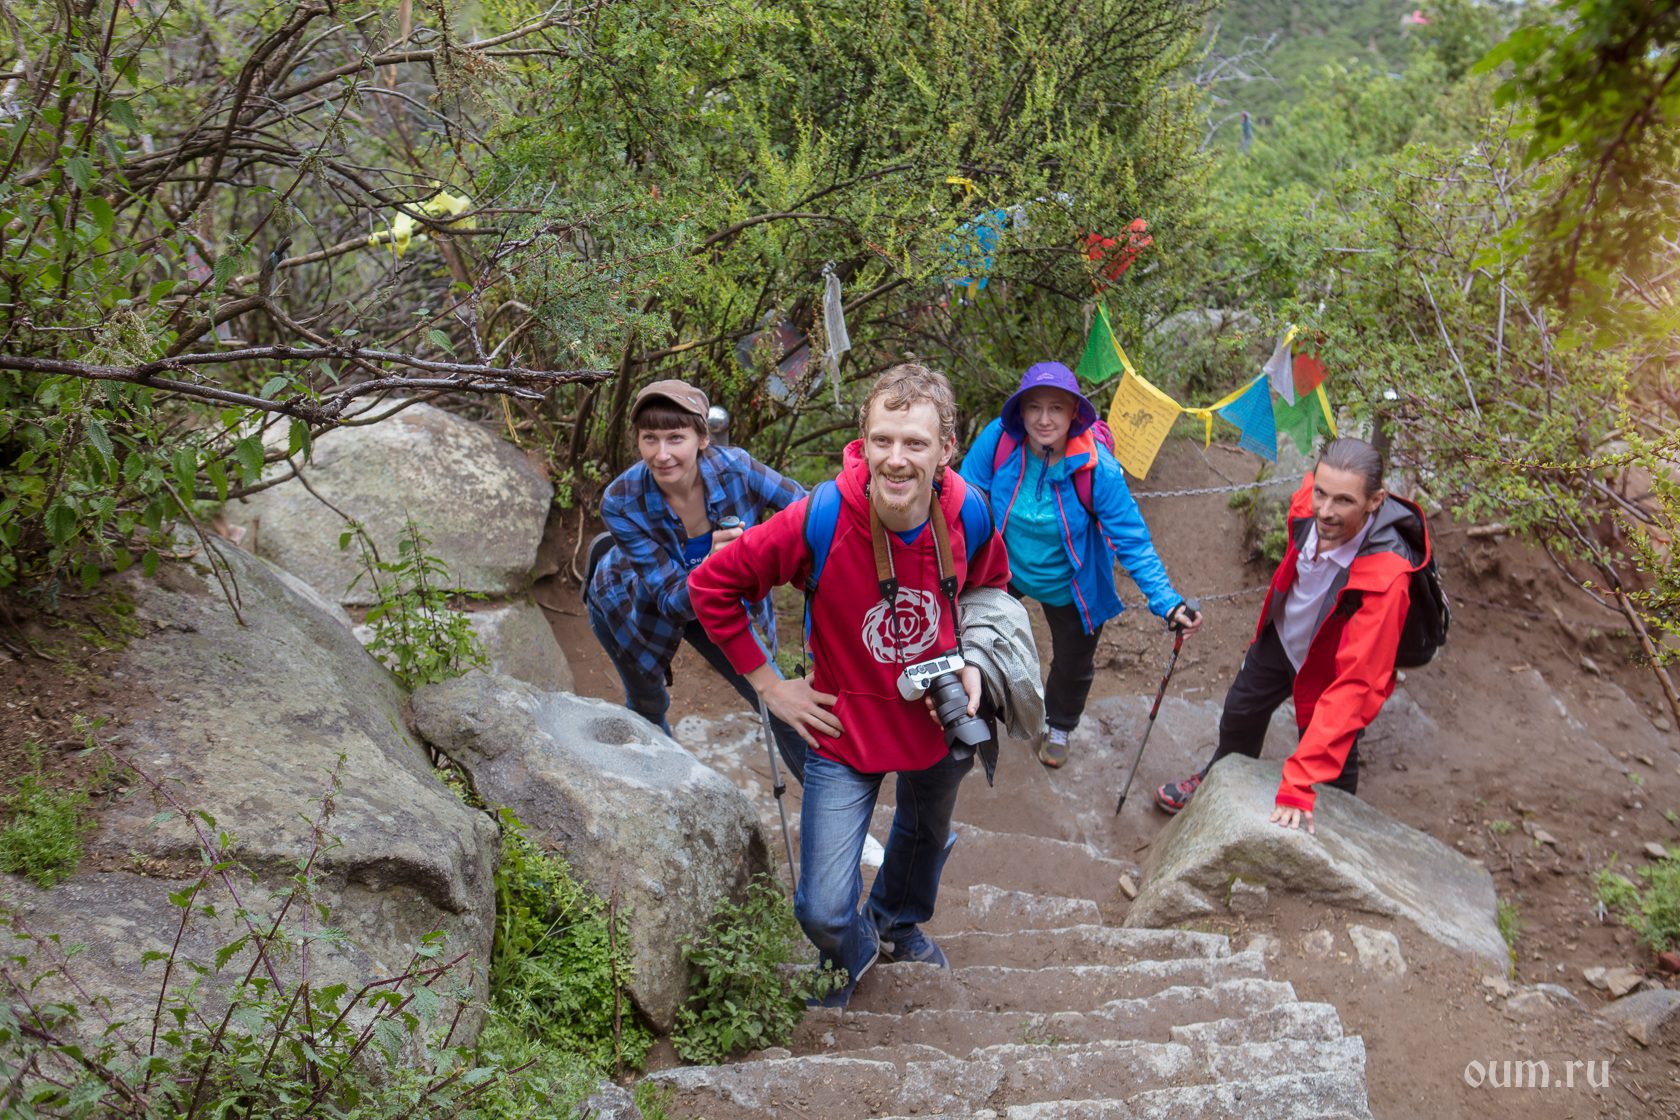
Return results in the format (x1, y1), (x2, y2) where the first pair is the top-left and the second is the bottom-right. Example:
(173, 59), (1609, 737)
(936, 926), (1231, 969)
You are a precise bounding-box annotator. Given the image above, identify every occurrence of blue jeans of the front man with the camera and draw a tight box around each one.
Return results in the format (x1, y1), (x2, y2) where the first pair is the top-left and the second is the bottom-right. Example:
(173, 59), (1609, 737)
(793, 752), (974, 1007)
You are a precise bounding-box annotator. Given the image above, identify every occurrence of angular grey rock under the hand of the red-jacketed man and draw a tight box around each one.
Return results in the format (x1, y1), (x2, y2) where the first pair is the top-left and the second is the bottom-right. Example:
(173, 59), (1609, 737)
(1124, 756), (1509, 969)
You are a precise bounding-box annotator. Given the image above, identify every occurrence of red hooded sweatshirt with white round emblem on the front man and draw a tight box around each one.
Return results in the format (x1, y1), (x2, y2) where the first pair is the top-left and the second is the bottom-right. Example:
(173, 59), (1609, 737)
(689, 440), (1010, 774)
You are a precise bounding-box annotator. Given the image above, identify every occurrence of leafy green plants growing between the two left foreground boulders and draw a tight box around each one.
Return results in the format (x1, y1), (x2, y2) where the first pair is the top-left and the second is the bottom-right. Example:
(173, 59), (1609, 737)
(491, 809), (654, 1070)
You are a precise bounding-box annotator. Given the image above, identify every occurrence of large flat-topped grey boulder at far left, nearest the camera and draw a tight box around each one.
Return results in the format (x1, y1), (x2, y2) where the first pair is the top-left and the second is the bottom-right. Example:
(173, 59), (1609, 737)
(3, 541), (499, 1039)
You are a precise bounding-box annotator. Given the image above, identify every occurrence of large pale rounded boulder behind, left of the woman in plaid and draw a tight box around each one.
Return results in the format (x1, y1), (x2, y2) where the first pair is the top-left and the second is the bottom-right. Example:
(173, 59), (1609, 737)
(223, 405), (554, 606)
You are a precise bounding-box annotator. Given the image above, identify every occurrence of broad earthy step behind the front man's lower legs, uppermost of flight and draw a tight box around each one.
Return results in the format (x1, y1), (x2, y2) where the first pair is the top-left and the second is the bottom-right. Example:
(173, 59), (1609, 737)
(869, 806), (1137, 905)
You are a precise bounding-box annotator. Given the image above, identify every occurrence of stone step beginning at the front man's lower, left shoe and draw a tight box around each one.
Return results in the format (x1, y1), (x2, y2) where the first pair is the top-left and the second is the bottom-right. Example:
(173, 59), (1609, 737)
(850, 950), (1265, 1014)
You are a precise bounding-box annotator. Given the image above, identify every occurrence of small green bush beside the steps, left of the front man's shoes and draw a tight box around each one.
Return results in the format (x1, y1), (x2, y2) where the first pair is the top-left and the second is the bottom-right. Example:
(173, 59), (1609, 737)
(670, 875), (845, 1063)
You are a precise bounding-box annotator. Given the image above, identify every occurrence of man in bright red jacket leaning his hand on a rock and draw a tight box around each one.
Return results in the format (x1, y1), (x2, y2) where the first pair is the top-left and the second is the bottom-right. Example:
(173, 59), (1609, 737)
(1156, 440), (1430, 833)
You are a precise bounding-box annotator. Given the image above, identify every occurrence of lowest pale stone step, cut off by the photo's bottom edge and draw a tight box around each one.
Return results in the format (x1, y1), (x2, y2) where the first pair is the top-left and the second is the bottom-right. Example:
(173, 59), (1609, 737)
(1001, 1073), (1371, 1120)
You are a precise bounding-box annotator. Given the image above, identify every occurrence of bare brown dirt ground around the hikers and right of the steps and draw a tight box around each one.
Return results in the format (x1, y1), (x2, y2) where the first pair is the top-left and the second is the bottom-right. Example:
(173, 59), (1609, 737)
(549, 442), (1680, 1120)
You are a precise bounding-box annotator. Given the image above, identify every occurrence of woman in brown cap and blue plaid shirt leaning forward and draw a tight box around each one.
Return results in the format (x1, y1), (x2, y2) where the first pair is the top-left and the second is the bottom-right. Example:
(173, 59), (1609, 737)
(586, 381), (805, 784)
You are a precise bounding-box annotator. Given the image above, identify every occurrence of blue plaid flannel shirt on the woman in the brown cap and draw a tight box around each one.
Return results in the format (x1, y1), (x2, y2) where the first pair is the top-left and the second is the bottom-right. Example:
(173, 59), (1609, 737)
(590, 447), (805, 677)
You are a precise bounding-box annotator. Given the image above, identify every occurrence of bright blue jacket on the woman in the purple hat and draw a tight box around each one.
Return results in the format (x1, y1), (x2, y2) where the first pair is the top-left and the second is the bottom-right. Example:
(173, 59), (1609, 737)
(959, 420), (1184, 633)
